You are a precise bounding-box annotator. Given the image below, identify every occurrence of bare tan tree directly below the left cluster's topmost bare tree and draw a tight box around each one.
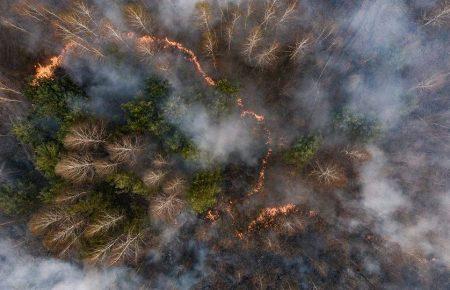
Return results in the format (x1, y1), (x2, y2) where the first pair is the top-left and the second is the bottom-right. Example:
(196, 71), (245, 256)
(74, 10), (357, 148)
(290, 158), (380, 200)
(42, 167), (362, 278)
(55, 155), (95, 183)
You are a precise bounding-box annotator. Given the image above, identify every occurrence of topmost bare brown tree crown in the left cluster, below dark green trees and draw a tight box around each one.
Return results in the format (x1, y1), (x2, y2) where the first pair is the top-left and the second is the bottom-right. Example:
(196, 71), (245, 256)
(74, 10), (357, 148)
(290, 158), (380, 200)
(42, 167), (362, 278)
(63, 122), (106, 150)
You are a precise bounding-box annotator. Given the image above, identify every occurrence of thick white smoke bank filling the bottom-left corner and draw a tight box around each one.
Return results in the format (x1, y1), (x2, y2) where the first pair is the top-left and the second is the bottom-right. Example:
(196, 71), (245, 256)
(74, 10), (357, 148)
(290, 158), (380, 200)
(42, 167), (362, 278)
(0, 238), (140, 290)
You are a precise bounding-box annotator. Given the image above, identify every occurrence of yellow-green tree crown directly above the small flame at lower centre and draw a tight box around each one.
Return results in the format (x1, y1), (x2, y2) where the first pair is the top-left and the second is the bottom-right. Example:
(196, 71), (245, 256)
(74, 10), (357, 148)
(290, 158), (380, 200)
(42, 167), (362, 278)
(187, 170), (222, 213)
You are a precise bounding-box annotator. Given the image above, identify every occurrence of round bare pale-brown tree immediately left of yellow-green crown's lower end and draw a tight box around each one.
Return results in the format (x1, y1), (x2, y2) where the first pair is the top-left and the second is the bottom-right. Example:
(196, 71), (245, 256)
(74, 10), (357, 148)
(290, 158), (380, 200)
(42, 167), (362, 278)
(150, 193), (185, 221)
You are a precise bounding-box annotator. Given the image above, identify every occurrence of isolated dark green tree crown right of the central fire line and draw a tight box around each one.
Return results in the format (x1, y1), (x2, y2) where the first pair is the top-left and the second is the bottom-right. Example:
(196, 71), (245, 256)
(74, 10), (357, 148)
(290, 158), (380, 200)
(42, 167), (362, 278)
(283, 136), (320, 168)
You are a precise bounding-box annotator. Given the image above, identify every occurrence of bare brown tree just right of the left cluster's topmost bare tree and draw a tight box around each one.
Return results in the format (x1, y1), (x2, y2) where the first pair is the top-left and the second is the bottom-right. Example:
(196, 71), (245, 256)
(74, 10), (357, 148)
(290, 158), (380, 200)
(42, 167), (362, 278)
(106, 136), (144, 165)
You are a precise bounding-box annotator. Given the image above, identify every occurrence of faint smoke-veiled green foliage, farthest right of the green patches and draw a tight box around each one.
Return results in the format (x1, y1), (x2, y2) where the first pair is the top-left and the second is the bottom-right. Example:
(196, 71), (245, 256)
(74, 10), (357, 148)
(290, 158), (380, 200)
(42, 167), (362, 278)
(333, 110), (381, 143)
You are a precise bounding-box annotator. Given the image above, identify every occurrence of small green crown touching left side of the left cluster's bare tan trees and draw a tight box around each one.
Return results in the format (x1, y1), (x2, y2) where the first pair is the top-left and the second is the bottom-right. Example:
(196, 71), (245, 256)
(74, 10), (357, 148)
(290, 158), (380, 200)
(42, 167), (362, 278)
(35, 143), (61, 178)
